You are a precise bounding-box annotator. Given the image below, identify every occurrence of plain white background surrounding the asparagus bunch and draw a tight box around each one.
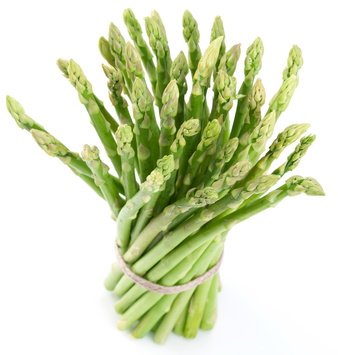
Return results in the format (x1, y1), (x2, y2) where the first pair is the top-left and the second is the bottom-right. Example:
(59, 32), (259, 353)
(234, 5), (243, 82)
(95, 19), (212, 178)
(0, 0), (338, 355)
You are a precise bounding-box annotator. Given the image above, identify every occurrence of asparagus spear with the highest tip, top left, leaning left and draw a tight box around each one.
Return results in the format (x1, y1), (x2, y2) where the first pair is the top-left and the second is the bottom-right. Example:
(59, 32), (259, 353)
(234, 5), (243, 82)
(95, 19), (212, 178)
(123, 9), (157, 93)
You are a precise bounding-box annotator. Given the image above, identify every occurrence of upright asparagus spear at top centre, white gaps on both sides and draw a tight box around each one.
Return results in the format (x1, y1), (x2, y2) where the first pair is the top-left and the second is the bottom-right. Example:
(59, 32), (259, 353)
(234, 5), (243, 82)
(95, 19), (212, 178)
(182, 10), (202, 77)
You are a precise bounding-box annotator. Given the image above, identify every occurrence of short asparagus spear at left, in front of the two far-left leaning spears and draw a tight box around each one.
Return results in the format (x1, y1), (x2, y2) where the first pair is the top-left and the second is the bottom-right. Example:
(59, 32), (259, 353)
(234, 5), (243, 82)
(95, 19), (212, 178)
(81, 145), (124, 220)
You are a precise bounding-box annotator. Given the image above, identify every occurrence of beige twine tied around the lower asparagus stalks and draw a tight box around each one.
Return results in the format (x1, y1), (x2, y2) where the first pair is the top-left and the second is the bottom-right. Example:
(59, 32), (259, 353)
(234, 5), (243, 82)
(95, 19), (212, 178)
(115, 244), (223, 295)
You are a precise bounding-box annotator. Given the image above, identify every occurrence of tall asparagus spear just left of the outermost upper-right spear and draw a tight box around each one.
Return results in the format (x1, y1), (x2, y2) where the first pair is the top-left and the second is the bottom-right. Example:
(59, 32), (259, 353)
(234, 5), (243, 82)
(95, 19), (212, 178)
(230, 37), (264, 138)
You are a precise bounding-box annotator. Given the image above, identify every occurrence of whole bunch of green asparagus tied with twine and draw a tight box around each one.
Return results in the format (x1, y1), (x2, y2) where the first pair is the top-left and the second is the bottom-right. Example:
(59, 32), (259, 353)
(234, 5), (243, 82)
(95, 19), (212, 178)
(7, 9), (324, 343)
